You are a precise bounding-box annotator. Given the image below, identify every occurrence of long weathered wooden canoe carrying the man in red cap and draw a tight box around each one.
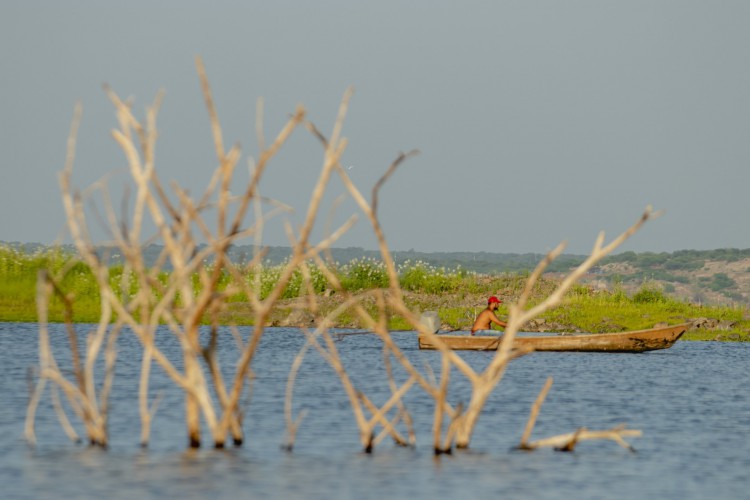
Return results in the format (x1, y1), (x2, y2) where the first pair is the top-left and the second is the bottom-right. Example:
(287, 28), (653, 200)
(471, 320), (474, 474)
(419, 323), (690, 352)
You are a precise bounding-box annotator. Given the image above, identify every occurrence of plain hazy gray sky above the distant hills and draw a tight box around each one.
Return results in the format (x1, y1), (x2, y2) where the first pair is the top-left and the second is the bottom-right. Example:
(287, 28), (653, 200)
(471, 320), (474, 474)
(0, 0), (750, 253)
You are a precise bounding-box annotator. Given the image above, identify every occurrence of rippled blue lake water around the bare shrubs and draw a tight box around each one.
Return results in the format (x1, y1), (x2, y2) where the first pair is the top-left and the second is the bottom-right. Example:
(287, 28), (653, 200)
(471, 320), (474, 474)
(0, 323), (750, 500)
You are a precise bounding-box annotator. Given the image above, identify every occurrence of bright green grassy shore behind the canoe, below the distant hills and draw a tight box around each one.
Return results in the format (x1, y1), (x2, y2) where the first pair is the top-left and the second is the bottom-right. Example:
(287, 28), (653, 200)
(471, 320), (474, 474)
(0, 247), (750, 341)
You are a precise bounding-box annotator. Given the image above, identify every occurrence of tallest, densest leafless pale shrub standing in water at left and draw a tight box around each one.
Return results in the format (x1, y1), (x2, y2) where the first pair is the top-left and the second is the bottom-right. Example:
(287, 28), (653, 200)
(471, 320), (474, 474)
(29, 60), (350, 447)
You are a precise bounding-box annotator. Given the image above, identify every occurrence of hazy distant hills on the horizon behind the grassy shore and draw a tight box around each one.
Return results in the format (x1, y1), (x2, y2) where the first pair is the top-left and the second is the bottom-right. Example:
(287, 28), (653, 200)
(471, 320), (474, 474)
(2, 242), (750, 307)
